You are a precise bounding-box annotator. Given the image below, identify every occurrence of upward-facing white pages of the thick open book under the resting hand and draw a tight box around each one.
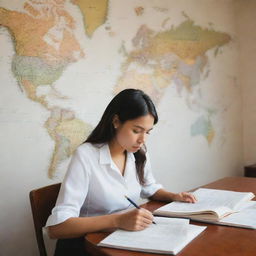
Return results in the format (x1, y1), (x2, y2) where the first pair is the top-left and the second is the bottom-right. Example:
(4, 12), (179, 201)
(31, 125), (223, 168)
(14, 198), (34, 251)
(154, 188), (253, 217)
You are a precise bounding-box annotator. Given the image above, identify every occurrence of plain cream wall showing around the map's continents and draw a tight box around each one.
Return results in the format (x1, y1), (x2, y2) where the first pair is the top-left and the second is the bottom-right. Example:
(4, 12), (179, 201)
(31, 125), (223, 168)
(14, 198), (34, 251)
(0, 0), (256, 256)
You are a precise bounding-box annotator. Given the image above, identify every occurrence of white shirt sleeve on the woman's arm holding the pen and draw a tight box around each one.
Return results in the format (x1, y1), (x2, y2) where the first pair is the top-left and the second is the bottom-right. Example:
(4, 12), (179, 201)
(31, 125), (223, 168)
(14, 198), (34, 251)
(46, 148), (90, 227)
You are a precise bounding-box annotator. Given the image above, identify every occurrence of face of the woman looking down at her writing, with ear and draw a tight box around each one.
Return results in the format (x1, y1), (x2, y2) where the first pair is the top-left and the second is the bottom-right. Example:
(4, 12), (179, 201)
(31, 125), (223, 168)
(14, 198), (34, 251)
(113, 114), (154, 153)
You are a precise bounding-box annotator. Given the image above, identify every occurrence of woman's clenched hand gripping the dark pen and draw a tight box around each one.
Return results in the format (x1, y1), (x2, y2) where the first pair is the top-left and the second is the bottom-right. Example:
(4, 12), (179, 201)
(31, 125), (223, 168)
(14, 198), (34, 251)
(117, 208), (153, 231)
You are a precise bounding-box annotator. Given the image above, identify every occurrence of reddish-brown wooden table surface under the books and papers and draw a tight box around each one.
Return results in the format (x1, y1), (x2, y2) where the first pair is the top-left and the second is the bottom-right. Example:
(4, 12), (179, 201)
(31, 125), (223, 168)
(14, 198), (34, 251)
(85, 177), (256, 256)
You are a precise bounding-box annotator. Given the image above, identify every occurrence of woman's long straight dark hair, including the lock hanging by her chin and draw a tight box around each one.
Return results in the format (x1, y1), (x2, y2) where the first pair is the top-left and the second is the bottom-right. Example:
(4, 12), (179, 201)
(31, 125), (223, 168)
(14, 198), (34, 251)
(85, 89), (158, 185)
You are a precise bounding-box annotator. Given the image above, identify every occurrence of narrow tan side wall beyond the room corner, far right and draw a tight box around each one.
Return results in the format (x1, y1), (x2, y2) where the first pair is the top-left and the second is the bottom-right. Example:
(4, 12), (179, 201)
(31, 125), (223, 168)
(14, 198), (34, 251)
(235, 0), (256, 165)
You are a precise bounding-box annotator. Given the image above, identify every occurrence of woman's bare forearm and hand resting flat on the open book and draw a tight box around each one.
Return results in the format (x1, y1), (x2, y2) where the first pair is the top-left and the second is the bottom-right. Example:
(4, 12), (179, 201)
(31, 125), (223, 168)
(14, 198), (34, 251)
(149, 188), (197, 203)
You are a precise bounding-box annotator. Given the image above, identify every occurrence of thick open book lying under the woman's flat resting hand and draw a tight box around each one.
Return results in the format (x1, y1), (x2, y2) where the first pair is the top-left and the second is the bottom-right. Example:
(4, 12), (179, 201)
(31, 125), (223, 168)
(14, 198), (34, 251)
(154, 188), (254, 221)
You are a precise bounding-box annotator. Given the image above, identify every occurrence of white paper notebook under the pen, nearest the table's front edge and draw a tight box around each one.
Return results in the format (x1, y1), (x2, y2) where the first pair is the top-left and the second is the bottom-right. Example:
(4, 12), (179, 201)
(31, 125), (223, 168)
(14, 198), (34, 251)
(98, 217), (206, 254)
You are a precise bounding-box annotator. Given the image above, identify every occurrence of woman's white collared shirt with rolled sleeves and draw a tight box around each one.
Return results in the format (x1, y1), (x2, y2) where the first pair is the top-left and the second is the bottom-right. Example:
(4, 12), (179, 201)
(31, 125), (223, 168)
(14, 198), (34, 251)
(46, 143), (162, 227)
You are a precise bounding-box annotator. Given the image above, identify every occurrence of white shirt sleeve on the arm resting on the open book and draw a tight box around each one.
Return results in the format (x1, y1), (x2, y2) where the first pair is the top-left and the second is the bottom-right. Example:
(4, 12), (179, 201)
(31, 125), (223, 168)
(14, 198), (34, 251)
(140, 154), (163, 198)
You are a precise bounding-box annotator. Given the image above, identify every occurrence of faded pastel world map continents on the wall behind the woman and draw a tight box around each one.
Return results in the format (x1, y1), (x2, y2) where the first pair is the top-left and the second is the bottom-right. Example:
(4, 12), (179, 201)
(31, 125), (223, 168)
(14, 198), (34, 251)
(0, 0), (231, 178)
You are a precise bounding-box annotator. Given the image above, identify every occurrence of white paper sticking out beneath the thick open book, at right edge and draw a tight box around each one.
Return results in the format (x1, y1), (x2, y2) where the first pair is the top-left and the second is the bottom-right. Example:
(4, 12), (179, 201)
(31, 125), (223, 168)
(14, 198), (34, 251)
(220, 201), (256, 229)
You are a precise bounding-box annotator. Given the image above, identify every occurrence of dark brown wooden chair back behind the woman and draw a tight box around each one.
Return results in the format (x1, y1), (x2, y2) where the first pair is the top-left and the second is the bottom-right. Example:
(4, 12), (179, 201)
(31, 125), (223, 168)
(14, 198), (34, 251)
(29, 183), (61, 256)
